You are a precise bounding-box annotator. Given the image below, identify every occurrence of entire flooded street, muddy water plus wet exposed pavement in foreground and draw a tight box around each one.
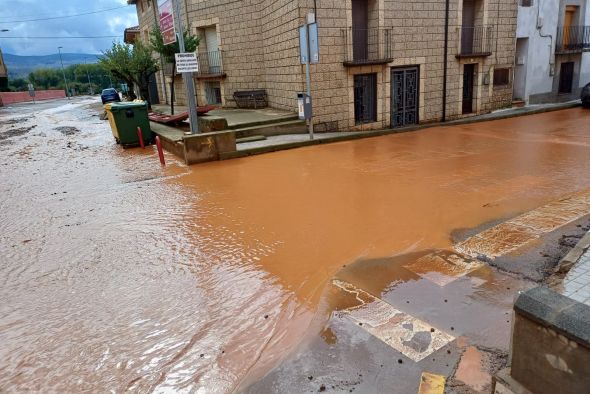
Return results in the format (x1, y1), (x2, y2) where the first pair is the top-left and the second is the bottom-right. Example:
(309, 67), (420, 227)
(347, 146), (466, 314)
(0, 99), (590, 393)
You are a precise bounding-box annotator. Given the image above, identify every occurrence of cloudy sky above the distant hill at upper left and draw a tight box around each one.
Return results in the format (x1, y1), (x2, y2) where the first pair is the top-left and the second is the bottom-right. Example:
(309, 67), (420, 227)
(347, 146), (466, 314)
(0, 0), (137, 55)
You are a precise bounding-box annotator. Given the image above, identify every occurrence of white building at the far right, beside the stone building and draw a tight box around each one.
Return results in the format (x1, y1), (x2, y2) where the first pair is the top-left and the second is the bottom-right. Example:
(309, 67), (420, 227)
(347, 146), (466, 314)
(513, 0), (590, 104)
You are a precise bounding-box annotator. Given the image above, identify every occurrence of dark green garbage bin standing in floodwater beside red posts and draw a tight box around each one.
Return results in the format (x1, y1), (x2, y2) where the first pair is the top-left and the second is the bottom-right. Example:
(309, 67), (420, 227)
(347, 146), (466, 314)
(105, 101), (153, 146)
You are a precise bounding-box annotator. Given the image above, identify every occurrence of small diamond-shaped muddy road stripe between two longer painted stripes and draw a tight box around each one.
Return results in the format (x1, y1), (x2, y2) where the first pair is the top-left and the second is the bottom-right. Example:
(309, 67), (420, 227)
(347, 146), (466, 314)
(404, 250), (483, 287)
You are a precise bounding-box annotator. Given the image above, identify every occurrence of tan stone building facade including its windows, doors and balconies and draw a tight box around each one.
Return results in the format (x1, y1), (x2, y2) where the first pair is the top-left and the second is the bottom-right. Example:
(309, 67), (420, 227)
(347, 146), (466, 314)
(131, 0), (517, 132)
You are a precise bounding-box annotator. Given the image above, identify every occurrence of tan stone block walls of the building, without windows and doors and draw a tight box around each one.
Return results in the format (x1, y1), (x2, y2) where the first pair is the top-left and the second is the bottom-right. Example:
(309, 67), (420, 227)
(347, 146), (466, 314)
(134, 0), (517, 131)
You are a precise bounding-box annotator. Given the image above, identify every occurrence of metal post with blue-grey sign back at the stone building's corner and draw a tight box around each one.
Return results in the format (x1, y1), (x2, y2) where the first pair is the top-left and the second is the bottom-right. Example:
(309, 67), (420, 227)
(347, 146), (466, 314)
(299, 12), (320, 140)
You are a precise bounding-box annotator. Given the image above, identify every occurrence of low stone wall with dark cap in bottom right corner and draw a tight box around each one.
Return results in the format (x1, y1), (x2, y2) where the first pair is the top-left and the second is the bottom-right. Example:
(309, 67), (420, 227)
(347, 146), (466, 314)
(494, 287), (590, 394)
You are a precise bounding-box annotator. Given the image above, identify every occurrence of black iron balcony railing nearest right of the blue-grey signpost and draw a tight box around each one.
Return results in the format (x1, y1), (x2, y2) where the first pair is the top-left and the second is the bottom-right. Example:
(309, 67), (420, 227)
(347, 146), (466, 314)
(342, 28), (393, 66)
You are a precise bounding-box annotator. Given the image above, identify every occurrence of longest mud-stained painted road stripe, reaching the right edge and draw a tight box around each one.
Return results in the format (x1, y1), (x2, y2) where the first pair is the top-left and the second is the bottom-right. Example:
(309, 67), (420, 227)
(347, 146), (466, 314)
(454, 190), (590, 259)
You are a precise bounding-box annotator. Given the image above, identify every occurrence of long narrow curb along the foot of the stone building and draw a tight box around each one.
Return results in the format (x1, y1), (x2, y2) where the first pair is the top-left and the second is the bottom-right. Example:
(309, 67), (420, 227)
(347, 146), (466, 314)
(225, 100), (582, 160)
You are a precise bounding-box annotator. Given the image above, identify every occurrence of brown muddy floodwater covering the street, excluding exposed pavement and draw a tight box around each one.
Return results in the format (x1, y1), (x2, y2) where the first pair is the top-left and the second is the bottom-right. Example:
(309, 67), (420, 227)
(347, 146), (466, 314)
(0, 99), (590, 393)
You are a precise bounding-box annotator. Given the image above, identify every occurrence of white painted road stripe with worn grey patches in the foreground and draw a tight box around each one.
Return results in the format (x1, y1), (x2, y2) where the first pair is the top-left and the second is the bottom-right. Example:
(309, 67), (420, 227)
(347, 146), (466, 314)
(332, 280), (455, 362)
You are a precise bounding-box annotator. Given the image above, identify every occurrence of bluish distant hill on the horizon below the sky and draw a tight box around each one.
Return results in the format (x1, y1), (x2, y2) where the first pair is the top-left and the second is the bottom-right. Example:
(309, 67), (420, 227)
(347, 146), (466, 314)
(3, 53), (100, 79)
